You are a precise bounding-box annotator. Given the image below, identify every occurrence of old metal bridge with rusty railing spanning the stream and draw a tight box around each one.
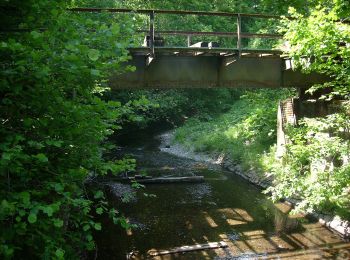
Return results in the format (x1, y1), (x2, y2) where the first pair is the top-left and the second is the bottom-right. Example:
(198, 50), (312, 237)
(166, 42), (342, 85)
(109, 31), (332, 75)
(70, 8), (327, 89)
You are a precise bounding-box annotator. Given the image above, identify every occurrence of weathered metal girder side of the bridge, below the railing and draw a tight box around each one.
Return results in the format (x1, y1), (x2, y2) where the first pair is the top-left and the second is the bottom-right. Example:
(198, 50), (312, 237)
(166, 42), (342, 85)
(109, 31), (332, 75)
(110, 47), (327, 89)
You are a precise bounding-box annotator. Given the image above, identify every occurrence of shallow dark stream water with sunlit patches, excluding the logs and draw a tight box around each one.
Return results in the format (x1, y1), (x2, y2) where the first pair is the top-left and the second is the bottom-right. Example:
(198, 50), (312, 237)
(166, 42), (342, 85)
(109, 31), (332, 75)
(91, 132), (350, 259)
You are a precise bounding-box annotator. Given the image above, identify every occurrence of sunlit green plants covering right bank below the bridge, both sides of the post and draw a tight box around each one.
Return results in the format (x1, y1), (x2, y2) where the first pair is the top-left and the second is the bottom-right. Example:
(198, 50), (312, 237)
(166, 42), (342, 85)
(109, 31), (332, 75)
(174, 90), (350, 236)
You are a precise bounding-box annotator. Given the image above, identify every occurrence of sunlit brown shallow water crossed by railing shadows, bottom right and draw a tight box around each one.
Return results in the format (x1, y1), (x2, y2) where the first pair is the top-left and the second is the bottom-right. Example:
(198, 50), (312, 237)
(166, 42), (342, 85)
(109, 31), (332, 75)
(159, 203), (350, 259)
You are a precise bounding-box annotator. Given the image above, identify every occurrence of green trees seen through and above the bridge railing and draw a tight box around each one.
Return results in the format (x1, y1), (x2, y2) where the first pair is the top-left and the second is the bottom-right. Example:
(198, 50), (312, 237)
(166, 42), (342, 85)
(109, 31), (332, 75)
(124, 0), (312, 48)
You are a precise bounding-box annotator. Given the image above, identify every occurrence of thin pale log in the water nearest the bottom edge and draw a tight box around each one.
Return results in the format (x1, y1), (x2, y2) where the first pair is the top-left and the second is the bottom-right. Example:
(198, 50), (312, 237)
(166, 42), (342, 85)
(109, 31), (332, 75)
(148, 241), (228, 257)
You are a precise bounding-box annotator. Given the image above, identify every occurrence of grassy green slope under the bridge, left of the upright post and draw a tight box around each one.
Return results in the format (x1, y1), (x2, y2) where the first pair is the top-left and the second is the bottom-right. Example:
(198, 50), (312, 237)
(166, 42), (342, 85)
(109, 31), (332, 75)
(175, 90), (291, 170)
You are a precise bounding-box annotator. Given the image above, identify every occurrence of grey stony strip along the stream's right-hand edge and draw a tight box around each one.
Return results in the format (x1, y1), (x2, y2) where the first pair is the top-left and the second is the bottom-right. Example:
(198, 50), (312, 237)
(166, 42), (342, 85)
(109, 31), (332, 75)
(157, 130), (350, 240)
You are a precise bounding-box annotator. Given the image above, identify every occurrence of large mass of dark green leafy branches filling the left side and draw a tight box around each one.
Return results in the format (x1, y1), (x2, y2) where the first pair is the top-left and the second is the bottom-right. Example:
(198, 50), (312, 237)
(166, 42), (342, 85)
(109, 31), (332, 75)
(0, 1), (141, 259)
